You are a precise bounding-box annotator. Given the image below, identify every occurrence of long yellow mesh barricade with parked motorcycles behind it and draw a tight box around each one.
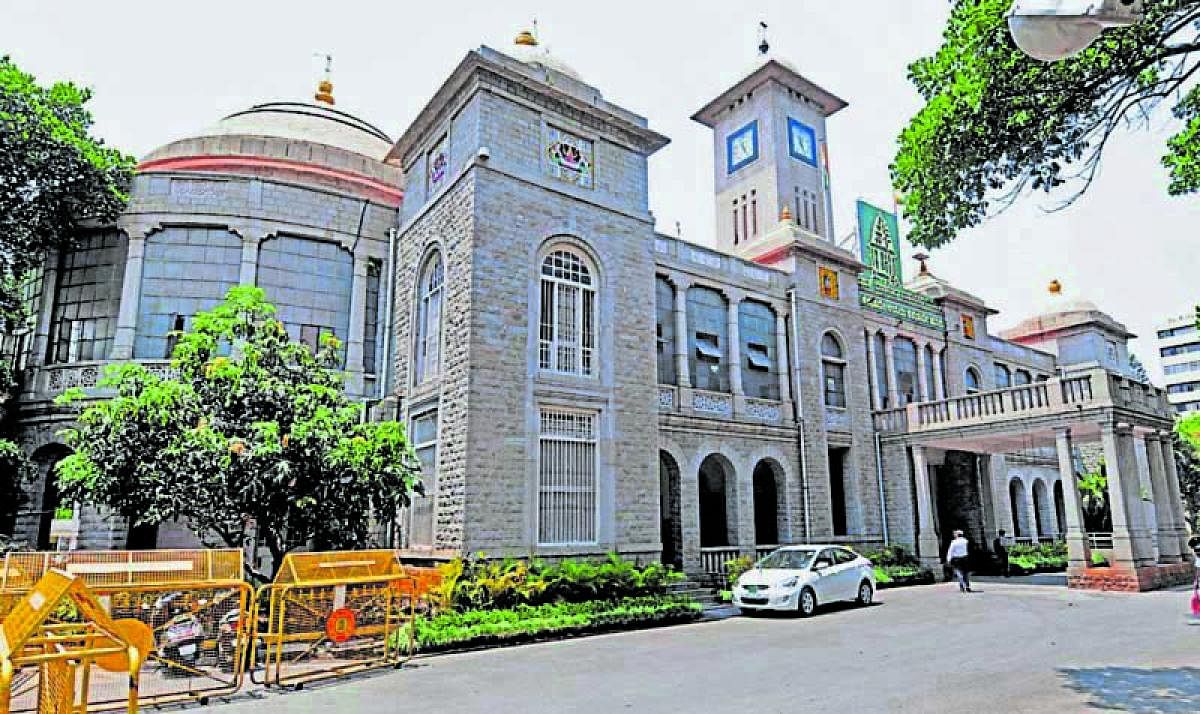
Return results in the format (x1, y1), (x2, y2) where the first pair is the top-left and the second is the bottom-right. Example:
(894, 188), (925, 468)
(0, 550), (253, 712)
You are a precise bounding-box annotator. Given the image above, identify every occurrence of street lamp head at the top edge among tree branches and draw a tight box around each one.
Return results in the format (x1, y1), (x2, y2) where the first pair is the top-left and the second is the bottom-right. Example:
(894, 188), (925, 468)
(1008, 0), (1142, 62)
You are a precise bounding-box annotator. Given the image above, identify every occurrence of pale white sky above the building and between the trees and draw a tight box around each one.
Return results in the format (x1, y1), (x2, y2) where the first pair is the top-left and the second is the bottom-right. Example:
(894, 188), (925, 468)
(0, 0), (1200, 379)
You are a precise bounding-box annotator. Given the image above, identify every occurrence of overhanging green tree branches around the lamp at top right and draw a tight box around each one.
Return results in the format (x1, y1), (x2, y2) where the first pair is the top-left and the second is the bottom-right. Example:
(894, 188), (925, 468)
(892, 0), (1200, 247)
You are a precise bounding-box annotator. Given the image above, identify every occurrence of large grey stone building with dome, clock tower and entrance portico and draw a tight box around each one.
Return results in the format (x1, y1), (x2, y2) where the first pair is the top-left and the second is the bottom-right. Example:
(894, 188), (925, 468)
(0, 34), (1190, 588)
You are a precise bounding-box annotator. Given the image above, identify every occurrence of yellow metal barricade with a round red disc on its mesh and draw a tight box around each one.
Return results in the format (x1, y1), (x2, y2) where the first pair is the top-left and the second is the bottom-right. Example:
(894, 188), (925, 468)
(253, 551), (441, 688)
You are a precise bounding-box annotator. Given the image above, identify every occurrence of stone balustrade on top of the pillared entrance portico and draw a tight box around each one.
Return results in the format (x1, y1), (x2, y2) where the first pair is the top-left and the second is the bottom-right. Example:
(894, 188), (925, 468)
(875, 370), (1171, 434)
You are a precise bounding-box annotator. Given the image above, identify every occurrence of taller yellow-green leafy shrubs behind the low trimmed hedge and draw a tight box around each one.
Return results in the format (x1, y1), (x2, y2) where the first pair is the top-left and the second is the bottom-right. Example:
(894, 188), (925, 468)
(449, 553), (684, 612)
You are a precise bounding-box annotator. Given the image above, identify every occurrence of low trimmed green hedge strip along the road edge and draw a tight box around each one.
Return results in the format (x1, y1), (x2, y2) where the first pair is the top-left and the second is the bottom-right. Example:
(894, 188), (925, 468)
(391, 595), (702, 652)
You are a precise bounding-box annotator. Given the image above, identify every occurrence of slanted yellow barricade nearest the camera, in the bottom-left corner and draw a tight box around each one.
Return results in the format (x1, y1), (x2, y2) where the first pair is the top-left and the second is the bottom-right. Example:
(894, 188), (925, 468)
(0, 570), (146, 714)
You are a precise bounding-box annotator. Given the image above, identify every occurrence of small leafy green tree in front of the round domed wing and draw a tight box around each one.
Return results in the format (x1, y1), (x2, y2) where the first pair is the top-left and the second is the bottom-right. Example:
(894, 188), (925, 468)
(58, 287), (421, 577)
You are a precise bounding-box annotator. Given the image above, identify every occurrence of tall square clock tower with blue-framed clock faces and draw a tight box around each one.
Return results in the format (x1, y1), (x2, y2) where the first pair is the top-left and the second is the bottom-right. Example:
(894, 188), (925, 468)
(692, 59), (846, 263)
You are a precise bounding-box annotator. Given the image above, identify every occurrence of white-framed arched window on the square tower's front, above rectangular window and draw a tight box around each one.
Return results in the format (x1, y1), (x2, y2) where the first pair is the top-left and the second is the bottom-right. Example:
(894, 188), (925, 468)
(538, 248), (596, 377)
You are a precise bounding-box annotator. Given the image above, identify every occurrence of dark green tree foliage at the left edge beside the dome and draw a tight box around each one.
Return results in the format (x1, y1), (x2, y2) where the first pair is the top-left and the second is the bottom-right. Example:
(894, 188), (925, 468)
(0, 56), (133, 320)
